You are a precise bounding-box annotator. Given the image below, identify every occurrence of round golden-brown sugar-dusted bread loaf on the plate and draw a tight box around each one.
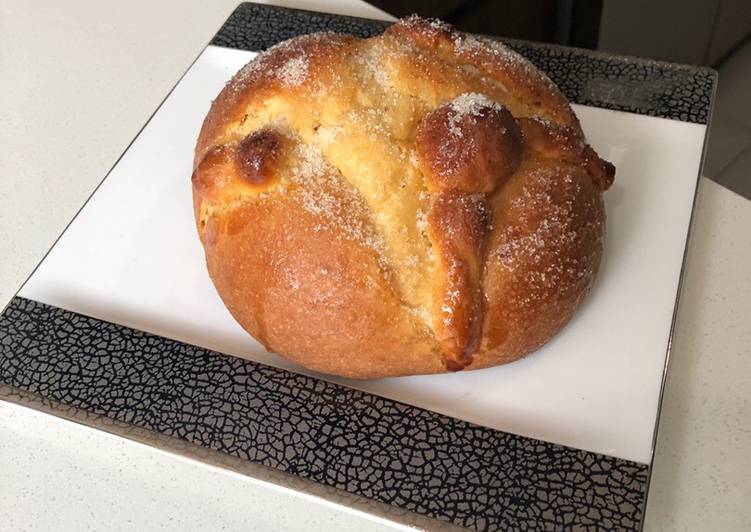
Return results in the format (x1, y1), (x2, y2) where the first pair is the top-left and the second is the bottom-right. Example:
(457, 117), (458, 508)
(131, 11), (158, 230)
(192, 17), (615, 378)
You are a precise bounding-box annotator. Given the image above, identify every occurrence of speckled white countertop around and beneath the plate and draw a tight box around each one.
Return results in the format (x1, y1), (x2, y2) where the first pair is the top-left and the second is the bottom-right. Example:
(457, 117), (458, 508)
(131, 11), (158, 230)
(0, 0), (751, 530)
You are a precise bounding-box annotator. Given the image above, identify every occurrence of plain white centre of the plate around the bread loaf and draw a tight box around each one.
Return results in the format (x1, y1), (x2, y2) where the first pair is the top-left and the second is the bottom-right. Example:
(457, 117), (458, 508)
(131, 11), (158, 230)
(19, 42), (706, 464)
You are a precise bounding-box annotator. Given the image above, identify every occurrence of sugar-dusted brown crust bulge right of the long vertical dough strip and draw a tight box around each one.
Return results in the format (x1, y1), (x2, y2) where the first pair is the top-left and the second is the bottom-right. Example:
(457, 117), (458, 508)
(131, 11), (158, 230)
(482, 159), (605, 367)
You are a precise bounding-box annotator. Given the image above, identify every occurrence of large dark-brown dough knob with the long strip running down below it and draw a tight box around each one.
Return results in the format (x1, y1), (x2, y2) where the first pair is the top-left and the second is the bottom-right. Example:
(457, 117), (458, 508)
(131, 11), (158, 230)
(415, 94), (523, 371)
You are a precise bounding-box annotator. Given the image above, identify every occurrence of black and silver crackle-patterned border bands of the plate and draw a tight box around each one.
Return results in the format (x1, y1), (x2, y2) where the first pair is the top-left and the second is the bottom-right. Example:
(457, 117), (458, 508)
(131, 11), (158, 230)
(0, 3), (716, 530)
